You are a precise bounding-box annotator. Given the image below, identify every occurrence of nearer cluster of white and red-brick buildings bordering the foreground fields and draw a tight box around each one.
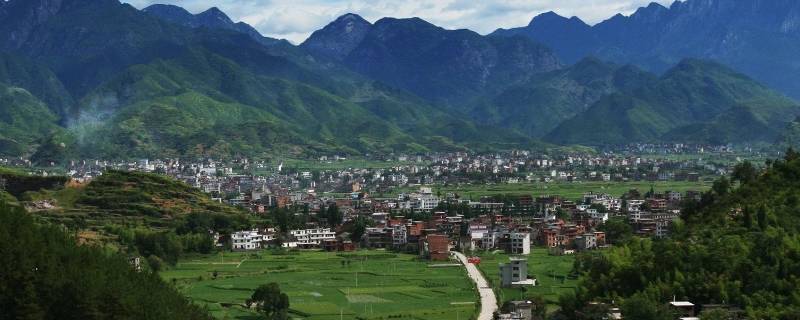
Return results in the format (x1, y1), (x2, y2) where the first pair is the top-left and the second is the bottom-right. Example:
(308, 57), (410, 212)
(222, 188), (700, 260)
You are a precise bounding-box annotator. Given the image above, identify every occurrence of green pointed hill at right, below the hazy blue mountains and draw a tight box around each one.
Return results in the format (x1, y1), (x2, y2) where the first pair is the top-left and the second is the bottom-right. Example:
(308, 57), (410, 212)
(546, 60), (800, 145)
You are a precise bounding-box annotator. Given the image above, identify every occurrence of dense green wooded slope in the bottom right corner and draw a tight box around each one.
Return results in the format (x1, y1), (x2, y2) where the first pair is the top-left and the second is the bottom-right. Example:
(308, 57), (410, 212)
(560, 150), (800, 319)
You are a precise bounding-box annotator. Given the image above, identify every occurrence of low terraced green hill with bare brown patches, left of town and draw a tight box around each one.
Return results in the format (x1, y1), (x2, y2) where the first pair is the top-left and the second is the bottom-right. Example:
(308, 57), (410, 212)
(23, 171), (252, 270)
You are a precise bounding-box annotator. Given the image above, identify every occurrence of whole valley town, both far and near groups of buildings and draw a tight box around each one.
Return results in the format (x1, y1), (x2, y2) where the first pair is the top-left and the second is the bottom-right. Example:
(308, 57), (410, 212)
(2, 149), (752, 320)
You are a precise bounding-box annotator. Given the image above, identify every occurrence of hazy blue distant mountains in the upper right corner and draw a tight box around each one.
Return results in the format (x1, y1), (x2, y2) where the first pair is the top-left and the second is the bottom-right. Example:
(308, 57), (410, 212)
(493, 0), (800, 98)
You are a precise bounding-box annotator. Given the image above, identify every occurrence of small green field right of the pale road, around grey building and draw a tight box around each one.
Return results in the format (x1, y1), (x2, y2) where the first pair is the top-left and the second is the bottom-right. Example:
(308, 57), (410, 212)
(478, 248), (578, 308)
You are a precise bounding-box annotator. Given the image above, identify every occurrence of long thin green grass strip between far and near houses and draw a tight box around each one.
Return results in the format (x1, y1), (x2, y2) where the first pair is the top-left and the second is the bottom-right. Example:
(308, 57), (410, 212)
(394, 181), (711, 201)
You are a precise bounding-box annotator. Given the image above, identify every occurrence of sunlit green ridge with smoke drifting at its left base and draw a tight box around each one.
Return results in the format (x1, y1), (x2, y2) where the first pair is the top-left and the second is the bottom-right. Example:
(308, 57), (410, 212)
(65, 49), (526, 157)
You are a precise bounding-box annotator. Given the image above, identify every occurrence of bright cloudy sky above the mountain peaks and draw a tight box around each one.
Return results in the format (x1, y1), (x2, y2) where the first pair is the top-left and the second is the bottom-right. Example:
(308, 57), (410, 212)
(123, 0), (673, 43)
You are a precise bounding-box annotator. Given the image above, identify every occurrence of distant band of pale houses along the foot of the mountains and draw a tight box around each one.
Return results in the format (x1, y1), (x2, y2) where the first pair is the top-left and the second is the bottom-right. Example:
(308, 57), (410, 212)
(10, 144), (758, 213)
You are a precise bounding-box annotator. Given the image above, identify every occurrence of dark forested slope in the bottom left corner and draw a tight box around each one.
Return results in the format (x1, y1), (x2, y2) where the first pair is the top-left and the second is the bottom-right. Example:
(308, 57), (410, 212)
(0, 203), (210, 319)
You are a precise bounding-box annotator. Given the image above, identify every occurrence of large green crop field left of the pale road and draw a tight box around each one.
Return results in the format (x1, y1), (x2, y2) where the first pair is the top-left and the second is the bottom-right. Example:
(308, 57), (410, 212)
(161, 251), (478, 320)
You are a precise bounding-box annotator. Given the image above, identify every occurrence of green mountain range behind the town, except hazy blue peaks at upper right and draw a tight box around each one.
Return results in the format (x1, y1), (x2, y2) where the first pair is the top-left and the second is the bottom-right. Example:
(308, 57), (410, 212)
(0, 0), (800, 162)
